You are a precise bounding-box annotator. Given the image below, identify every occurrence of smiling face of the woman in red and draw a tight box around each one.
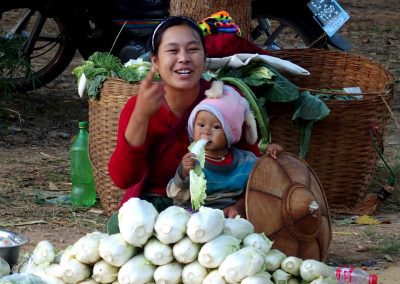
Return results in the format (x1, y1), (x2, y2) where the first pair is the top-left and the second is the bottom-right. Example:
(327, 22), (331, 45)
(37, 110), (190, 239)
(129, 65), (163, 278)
(152, 25), (205, 90)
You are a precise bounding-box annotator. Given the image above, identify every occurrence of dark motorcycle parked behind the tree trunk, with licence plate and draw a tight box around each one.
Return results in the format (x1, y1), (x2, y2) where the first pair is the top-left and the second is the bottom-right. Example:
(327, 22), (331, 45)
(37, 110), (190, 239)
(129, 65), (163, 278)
(0, 0), (351, 91)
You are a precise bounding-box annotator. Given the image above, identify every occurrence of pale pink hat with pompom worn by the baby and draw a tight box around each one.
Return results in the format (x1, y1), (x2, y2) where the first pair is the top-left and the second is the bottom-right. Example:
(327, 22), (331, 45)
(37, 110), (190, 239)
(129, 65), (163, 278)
(188, 81), (257, 148)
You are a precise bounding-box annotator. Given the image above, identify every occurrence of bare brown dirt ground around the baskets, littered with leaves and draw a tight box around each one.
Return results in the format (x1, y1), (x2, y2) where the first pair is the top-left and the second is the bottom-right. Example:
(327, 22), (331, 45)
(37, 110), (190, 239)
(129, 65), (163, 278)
(0, 0), (400, 283)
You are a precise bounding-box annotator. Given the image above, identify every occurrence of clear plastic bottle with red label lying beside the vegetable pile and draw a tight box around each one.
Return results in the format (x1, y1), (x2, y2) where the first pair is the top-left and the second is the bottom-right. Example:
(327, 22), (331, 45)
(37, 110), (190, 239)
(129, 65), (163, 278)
(335, 267), (378, 284)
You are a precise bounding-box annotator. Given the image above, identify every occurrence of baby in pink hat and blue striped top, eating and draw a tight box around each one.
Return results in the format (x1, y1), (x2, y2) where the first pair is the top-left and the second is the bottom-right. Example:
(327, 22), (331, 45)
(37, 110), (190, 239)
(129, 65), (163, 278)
(167, 82), (283, 218)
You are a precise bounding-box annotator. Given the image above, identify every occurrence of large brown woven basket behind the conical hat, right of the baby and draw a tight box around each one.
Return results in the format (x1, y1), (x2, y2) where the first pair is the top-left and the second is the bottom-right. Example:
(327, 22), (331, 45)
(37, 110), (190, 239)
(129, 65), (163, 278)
(268, 49), (394, 214)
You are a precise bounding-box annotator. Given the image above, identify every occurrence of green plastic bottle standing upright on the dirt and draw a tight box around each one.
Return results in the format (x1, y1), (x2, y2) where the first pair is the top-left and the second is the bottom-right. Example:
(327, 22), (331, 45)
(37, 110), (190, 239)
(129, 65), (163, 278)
(70, 121), (96, 207)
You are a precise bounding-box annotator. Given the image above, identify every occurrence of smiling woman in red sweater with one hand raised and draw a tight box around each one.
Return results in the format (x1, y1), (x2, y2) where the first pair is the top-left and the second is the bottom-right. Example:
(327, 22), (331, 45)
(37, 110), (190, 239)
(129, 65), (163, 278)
(109, 16), (259, 215)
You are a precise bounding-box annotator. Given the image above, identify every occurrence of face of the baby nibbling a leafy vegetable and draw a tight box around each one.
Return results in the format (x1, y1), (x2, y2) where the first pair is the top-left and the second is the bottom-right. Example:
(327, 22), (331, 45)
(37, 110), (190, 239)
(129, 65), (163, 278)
(193, 110), (227, 151)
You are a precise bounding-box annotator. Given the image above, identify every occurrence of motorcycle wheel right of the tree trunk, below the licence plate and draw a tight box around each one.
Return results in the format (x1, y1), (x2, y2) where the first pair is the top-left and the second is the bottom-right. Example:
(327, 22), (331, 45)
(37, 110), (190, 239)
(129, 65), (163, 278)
(251, 15), (328, 51)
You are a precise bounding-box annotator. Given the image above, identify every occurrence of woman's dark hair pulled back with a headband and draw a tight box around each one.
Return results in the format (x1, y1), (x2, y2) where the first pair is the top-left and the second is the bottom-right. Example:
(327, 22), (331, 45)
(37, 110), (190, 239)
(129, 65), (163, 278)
(150, 16), (205, 55)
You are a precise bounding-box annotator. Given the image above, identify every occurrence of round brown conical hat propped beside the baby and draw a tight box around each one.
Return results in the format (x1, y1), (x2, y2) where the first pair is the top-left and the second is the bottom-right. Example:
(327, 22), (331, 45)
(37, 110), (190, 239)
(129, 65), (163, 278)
(246, 153), (332, 260)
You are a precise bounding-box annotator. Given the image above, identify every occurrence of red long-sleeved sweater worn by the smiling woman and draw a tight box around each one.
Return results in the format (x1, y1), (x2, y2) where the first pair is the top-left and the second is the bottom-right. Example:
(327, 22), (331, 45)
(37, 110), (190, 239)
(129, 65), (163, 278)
(108, 81), (260, 205)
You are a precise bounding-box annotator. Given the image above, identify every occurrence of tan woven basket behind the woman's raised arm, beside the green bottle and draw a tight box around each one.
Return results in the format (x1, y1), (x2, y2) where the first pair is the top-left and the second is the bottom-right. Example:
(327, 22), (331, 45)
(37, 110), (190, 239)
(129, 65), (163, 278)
(89, 78), (139, 215)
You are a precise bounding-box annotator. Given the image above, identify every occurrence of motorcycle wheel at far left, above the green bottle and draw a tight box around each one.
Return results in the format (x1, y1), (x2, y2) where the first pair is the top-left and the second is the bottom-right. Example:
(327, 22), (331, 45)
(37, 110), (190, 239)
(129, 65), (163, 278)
(0, 7), (76, 91)
